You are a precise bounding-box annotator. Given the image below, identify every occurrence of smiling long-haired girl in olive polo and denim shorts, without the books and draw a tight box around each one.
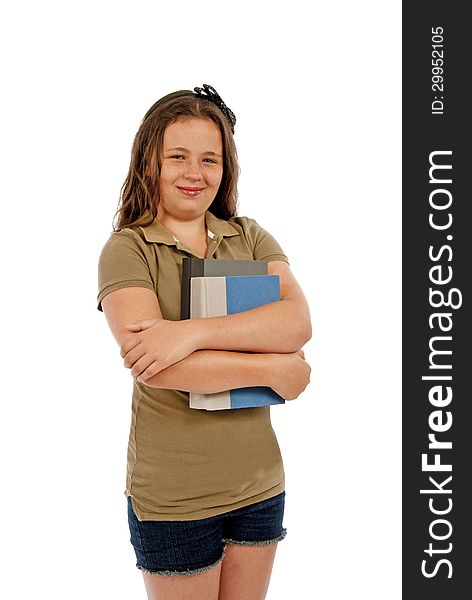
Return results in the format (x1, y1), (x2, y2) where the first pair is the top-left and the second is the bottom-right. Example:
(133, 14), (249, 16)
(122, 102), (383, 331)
(98, 84), (311, 600)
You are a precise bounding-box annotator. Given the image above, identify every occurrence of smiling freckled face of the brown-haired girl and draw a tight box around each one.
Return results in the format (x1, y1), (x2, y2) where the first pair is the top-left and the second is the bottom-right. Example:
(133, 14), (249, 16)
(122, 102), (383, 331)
(157, 118), (223, 224)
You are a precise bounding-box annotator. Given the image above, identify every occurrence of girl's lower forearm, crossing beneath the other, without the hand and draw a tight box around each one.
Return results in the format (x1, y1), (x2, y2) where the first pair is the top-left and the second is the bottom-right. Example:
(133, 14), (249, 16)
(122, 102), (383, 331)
(145, 350), (272, 394)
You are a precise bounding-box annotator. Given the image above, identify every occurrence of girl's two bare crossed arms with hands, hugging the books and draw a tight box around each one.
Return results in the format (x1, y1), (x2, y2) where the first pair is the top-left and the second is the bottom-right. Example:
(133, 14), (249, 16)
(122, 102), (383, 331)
(102, 261), (311, 399)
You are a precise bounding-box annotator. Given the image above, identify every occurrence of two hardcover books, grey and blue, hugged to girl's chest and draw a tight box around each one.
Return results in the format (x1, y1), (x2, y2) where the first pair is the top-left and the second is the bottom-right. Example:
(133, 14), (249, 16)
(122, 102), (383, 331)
(181, 258), (285, 410)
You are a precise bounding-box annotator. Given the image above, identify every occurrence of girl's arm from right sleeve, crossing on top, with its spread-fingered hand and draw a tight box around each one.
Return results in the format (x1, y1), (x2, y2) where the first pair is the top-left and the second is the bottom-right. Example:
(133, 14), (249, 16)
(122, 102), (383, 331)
(121, 261), (311, 380)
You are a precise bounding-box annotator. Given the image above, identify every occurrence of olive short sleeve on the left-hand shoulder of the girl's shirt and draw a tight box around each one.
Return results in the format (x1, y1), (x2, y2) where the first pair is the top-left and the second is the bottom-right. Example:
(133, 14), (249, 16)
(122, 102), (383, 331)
(97, 229), (157, 312)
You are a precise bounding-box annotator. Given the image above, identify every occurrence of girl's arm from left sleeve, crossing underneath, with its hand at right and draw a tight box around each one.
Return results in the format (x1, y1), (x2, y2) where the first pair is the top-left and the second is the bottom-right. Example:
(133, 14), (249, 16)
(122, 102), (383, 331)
(102, 287), (310, 400)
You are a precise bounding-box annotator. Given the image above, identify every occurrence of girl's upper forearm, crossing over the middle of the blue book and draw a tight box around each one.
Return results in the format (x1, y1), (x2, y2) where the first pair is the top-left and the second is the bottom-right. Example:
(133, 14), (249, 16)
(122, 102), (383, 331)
(185, 300), (311, 353)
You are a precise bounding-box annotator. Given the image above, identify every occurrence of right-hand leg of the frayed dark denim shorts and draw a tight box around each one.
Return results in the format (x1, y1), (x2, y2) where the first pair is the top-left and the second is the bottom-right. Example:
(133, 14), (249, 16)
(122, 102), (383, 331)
(223, 491), (287, 546)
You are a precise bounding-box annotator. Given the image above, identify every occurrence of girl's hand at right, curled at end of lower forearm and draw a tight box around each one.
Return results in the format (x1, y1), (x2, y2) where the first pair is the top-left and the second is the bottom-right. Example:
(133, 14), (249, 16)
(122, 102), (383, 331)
(270, 350), (311, 400)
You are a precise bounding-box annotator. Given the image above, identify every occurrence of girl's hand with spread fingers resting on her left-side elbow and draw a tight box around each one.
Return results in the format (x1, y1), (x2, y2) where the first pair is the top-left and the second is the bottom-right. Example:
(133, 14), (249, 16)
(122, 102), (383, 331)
(120, 319), (197, 382)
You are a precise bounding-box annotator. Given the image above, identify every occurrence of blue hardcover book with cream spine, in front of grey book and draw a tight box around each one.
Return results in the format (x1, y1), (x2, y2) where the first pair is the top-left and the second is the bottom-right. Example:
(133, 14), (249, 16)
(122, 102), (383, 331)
(189, 275), (285, 410)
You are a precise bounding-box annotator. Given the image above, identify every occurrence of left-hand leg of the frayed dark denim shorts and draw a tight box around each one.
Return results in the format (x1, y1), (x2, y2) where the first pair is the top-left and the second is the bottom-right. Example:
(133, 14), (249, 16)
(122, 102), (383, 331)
(128, 497), (224, 579)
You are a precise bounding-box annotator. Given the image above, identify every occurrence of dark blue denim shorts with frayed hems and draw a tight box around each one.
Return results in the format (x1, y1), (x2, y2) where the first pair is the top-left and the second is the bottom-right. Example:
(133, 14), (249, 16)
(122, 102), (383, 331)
(128, 491), (287, 575)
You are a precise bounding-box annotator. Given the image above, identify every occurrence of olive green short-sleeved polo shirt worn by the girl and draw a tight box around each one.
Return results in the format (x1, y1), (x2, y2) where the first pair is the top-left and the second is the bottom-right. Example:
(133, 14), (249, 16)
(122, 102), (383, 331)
(97, 211), (288, 521)
